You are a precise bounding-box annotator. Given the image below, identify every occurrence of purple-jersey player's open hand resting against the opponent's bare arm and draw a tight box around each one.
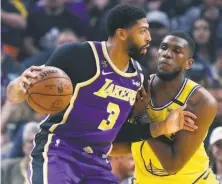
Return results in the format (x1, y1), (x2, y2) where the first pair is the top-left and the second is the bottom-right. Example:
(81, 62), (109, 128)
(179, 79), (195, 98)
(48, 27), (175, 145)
(164, 104), (198, 134)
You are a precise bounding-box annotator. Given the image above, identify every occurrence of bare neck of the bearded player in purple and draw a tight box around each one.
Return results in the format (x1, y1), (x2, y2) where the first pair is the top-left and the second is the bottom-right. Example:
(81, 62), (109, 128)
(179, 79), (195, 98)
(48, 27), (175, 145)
(107, 38), (130, 72)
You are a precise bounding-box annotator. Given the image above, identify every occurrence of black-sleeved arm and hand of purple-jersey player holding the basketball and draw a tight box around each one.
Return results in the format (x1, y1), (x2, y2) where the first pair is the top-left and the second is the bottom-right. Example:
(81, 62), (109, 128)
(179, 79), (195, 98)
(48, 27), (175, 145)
(7, 42), (96, 103)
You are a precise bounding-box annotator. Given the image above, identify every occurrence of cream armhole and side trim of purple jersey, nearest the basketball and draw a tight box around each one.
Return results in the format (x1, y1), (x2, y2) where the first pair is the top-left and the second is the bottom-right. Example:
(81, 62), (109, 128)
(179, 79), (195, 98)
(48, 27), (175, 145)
(49, 42), (100, 132)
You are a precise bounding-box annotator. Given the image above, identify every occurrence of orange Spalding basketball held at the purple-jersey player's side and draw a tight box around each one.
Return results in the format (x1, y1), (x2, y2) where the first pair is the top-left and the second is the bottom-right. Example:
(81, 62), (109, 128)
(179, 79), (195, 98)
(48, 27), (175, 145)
(25, 66), (73, 114)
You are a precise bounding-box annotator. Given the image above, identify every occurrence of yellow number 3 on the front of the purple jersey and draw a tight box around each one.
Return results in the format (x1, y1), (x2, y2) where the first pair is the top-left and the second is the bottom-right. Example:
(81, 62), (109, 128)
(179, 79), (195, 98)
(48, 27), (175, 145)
(98, 102), (120, 131)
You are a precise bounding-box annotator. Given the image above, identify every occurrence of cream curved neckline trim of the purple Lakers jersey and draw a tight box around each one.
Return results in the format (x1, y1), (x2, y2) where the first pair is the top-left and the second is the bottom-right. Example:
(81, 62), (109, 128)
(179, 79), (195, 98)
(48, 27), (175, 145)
(102, 41), (137, 77)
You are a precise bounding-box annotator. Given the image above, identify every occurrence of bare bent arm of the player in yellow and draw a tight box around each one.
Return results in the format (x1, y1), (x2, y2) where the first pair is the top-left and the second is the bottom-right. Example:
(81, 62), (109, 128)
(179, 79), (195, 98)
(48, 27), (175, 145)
(147, 88), (217, 174)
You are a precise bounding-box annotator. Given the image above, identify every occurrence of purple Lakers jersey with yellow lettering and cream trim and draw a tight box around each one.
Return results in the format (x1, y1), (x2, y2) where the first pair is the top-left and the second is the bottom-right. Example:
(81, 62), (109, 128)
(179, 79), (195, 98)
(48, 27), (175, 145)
(40, 42), (144, 154)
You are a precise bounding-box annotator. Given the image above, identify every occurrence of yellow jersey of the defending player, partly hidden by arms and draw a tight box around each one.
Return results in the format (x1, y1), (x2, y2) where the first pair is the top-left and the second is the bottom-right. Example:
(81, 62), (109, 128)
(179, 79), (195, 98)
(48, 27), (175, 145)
(132, 75), (217, 184)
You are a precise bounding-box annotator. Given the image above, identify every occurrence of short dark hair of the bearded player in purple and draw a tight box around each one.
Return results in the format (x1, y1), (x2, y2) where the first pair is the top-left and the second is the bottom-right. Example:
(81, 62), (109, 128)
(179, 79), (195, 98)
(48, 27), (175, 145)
(106, 4), (146, 36)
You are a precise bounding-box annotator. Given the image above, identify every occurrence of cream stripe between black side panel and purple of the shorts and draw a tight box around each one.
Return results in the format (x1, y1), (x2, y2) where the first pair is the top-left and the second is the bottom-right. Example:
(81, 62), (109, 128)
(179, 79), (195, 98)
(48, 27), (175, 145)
(42, 134), (55, 184)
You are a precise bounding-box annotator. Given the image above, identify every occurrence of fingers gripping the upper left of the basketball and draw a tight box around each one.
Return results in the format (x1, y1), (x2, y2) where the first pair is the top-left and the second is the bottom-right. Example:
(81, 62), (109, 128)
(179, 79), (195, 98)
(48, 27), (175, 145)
(18, 65), (45, 93)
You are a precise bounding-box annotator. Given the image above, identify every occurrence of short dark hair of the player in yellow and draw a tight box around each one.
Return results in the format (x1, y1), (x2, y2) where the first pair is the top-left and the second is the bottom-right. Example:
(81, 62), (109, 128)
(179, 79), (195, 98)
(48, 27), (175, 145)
(167, 31), (195, 58)
